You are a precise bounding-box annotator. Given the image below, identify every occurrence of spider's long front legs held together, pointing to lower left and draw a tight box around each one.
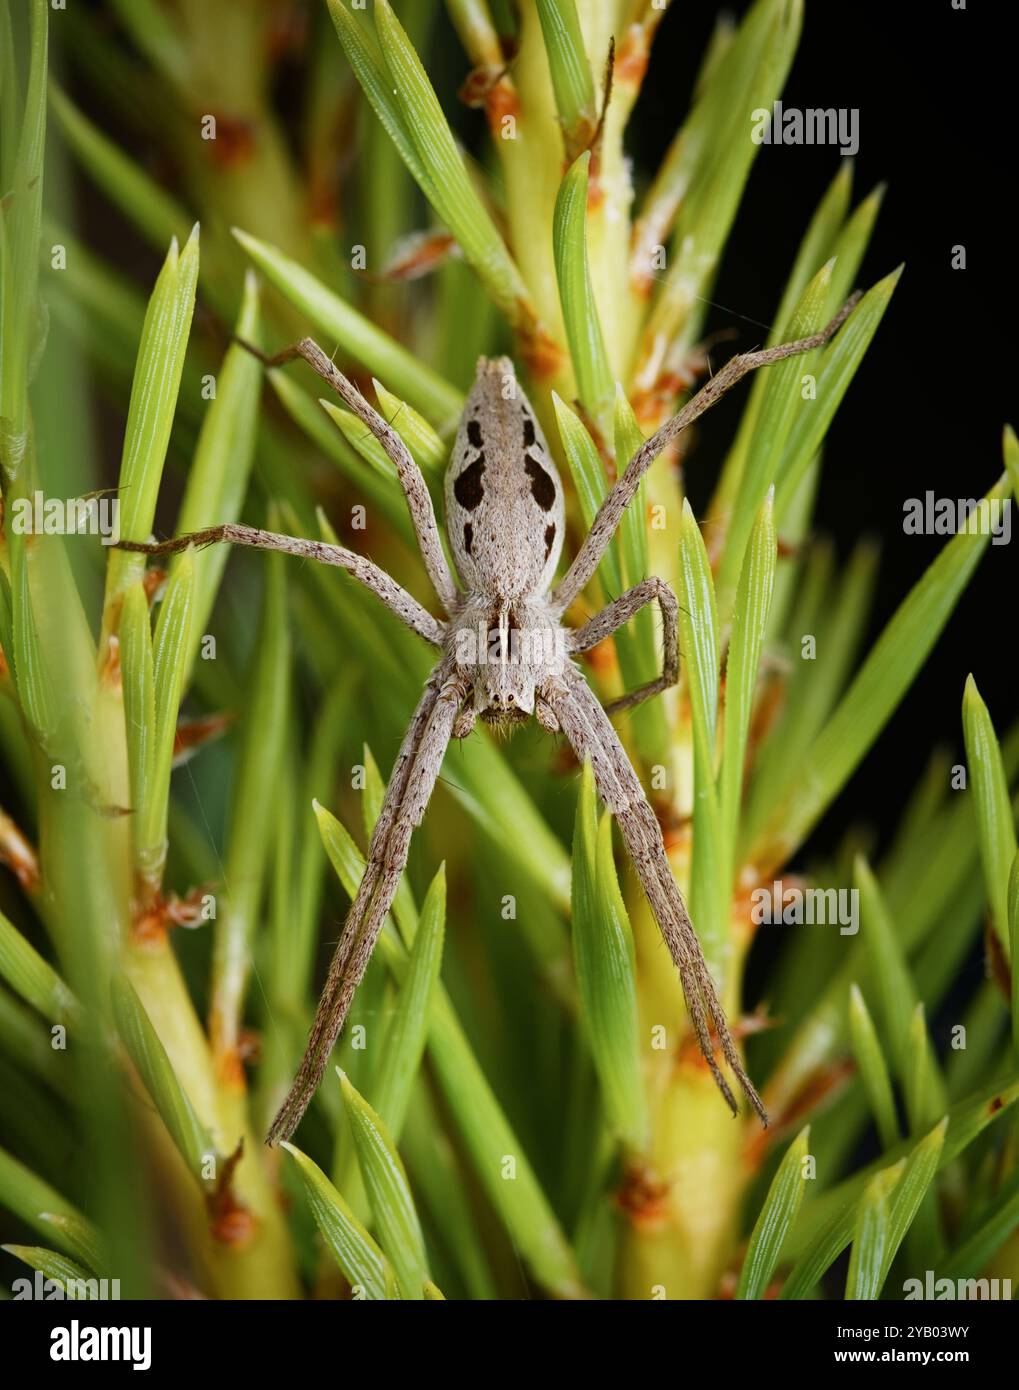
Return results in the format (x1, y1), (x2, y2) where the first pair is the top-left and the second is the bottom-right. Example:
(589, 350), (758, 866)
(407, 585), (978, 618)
(266, 657), (466, 1144)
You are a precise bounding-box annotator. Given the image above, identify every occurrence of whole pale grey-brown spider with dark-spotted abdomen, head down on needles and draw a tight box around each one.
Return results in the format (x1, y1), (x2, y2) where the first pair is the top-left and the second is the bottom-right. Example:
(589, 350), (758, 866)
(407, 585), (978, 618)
(120, 295), (859, 1144)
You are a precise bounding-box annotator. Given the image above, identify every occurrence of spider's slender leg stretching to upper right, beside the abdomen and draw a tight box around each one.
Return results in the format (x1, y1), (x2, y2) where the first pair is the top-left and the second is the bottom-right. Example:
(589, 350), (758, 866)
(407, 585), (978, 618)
(549, 293), (861, 613)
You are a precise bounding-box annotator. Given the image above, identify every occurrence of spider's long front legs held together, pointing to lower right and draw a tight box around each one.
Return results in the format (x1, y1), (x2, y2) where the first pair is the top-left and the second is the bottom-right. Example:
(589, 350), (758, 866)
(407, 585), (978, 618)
(545, 666), (767, 1125)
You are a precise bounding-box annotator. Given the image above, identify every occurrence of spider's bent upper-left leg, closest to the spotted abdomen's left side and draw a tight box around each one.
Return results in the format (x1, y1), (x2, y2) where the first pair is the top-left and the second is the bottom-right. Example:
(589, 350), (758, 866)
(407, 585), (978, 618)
(238, 338), (459, 613)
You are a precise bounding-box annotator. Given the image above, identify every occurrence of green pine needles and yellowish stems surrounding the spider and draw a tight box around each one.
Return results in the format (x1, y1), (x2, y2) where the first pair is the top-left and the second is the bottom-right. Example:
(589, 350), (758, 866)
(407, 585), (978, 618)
(0, 0), (1019, 1298)
